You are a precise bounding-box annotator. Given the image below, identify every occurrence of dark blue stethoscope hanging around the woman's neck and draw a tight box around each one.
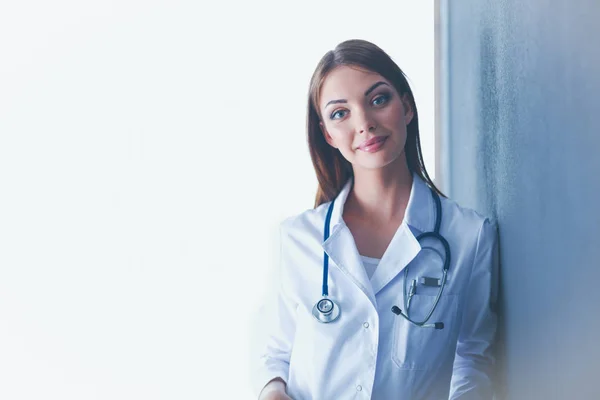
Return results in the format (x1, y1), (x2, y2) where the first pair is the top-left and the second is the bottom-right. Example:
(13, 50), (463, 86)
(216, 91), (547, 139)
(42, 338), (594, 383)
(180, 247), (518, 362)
(312, 189), (451, 329)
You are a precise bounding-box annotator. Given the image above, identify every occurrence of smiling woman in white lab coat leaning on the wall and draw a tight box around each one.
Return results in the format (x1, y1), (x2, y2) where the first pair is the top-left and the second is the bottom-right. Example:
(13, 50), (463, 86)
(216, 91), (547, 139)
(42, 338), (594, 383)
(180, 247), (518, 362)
(254, 40), (497, 400)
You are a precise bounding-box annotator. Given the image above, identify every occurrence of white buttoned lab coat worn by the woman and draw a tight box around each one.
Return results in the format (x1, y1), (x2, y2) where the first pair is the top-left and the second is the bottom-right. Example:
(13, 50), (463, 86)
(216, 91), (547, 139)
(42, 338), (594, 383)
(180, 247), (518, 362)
(253, 174), (497, 400)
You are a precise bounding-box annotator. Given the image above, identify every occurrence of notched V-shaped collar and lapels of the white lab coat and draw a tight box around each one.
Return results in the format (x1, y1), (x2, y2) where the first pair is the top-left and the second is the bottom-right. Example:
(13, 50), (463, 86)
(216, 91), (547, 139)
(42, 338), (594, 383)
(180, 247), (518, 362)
(323, 173), (435, 306)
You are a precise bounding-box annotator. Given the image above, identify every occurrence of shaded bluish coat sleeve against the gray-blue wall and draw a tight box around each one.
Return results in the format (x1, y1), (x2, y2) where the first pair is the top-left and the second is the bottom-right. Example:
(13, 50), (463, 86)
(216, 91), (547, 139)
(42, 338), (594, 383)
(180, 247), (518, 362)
(450, 218), (498, 400)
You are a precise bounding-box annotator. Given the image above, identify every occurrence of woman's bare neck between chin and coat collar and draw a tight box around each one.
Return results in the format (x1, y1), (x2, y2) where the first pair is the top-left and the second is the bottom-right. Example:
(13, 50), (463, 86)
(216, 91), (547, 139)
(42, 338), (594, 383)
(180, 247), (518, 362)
(344, 157), (413, 223)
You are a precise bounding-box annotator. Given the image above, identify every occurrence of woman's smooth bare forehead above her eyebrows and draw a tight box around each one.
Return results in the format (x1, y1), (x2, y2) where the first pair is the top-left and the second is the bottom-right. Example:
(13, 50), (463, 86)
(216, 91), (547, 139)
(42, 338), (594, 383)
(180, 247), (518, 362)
(319, 65), (392, 107)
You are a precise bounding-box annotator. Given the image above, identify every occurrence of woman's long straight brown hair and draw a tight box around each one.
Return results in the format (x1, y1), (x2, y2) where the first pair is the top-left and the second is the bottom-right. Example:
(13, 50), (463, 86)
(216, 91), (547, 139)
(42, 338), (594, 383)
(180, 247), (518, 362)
(307, 39), (446, 208)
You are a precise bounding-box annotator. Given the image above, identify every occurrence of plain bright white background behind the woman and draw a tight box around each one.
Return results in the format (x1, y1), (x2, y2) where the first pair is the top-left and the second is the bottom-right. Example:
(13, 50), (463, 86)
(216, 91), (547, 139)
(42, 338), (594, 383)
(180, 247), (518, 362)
(0, 0), (435, 400)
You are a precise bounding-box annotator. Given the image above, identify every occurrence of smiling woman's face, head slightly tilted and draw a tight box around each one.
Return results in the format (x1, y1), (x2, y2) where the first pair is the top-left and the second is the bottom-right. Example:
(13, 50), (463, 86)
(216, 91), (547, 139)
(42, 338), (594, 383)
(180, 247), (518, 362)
(318, 66), (413, 169)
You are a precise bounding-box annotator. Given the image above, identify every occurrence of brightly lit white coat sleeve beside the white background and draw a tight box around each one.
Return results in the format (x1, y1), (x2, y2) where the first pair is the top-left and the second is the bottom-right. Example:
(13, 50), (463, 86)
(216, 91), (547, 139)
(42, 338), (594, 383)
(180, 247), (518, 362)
(252, 224), (297, 397)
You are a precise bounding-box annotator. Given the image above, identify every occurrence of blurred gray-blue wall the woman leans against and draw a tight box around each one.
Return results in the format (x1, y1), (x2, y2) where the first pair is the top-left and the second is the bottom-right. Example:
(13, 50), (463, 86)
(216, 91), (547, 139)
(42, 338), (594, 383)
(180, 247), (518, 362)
(438, 0), (600, 399)
